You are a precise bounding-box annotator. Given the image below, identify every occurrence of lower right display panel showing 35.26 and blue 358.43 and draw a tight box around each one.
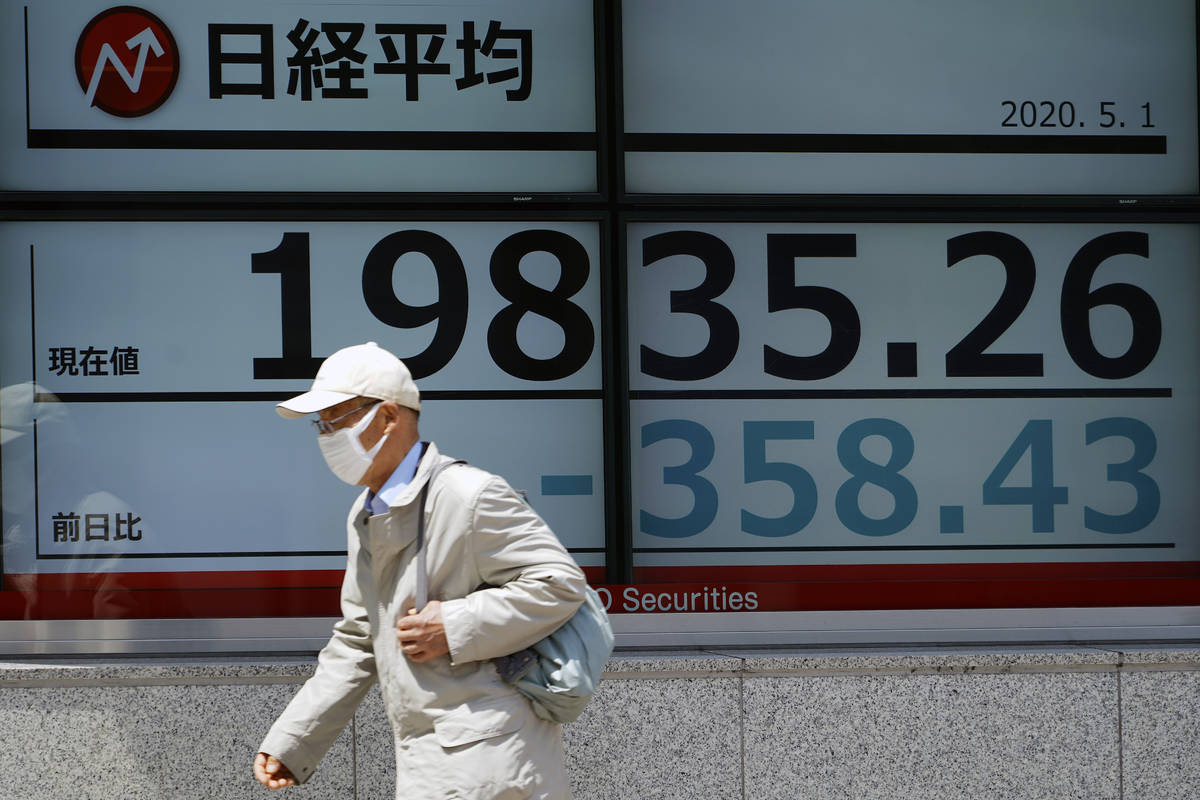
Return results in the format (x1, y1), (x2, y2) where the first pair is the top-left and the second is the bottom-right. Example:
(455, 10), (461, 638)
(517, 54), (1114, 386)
(626, 221), (1200, 610)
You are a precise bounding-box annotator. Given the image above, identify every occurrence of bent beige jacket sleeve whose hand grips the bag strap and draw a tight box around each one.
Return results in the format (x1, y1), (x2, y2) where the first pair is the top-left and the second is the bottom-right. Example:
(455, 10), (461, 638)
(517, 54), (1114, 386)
(442, 476), (587, 664)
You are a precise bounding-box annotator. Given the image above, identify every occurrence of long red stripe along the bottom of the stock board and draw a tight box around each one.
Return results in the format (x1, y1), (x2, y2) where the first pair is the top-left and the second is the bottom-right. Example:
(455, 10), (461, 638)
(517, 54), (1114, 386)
(0, 561), (1200, 620)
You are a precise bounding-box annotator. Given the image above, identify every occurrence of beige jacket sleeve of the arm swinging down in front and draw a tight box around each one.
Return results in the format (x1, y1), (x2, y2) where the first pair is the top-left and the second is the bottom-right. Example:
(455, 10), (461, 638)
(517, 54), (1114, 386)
(259, 515), (376, 783)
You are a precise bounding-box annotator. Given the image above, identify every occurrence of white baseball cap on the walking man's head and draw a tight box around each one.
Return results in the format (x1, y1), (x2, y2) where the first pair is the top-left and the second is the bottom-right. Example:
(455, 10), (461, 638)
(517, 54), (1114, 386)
(275, 342), (421, 419)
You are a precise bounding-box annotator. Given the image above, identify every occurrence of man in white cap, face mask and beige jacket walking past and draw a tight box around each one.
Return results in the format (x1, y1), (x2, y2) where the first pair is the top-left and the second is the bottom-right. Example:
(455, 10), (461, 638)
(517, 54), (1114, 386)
(253, 342), (586, 800)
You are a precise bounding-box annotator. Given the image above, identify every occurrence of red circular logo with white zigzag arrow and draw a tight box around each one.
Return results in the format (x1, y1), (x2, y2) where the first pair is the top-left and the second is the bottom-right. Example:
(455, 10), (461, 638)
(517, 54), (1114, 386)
(76, 6), (179, 116)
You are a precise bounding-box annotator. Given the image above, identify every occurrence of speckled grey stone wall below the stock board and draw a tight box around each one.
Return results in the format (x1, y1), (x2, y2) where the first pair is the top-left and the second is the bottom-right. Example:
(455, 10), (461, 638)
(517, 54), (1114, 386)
(0, 644), (1200, 800)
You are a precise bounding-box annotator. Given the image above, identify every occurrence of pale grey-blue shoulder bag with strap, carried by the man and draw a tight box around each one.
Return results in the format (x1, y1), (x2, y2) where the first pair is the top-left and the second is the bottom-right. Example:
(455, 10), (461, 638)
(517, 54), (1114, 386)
(416, 461), (613, 723)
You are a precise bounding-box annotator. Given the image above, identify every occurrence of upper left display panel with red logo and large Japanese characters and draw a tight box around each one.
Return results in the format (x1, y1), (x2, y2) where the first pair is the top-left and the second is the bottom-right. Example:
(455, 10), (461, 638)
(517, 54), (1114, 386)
(0, 0), (598, 196)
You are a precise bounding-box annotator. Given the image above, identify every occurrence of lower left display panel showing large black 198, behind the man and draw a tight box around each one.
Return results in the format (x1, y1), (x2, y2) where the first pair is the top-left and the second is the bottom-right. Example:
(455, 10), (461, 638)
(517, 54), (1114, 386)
(0, 221), (605, 618)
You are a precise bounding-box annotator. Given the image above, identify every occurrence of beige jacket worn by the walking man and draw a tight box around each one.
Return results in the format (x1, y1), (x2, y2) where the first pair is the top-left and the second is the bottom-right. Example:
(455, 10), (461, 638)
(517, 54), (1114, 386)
(259, 444), (586, 800)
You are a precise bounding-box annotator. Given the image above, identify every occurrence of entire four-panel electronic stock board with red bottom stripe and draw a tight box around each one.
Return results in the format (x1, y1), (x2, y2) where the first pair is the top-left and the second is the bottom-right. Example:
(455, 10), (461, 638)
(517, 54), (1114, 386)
(0, 0), (1200, 627)
